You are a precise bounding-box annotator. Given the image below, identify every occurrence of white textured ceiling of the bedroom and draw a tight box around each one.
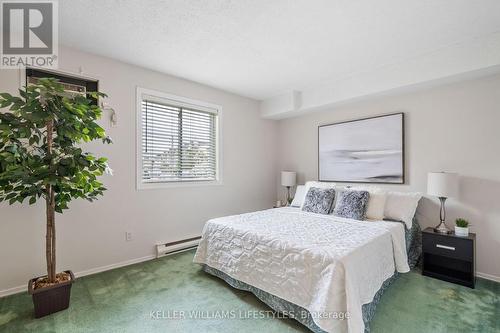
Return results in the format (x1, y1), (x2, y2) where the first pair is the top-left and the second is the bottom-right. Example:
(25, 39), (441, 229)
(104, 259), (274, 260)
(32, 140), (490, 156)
(59, 0), (500, 106)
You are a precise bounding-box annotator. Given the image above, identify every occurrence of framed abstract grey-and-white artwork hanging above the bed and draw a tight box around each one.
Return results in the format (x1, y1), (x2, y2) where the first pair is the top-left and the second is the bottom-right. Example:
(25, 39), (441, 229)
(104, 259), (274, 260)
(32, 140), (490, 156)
(318, 113), (405, 184)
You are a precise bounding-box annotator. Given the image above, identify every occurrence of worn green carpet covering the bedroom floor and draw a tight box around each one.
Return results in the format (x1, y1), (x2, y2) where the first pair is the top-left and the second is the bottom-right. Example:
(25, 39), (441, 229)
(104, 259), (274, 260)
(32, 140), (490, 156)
(0, 251), (500, 333)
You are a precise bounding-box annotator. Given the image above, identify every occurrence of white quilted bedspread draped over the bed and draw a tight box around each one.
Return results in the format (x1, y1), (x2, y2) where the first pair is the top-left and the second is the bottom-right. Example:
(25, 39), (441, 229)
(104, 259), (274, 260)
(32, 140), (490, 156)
(194, 208), (410, 332)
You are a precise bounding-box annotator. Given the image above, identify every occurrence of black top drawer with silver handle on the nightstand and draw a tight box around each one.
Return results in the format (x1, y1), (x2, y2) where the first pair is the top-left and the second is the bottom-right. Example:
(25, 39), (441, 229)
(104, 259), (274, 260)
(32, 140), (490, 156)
(422, 234), (474, 261)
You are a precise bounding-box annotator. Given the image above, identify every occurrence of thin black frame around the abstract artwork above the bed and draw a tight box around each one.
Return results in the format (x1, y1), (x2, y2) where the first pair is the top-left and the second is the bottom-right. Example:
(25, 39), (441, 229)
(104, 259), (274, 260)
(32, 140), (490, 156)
(317, 112), (406, 185)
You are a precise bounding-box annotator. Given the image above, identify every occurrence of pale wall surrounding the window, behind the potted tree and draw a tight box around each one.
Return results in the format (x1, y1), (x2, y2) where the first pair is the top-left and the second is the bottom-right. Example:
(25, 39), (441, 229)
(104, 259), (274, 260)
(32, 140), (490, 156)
(0, 48), (277, 292)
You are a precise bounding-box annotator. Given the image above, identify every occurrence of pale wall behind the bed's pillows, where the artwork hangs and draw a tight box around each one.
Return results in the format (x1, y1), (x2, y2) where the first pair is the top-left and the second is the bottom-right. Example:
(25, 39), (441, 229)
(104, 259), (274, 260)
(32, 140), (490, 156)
(276, 75), (500, 279)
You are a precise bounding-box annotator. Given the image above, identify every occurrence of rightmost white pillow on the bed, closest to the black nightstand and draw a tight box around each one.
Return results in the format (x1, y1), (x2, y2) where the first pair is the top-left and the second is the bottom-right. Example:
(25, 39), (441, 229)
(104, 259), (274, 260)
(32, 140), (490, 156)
(384, 192), (422, 229)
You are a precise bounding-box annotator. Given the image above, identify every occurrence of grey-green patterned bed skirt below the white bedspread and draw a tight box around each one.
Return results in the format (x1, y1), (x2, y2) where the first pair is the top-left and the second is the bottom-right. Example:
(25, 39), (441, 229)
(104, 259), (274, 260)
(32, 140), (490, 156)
(202, 219), (422, 333)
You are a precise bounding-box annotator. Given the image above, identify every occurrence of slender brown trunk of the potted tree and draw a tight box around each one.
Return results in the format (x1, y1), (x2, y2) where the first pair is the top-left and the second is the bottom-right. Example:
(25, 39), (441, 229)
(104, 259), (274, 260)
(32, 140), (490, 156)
(45, 120), (56, 283)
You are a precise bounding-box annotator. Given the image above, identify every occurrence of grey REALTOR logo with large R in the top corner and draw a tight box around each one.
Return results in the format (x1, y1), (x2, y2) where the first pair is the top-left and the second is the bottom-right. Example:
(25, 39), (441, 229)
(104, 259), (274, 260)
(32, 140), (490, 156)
(0, 0), (58, 68)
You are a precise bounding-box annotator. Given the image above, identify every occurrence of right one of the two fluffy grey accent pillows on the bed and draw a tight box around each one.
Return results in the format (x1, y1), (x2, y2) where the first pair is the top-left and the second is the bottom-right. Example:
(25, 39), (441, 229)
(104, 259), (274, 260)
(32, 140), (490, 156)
(333, 190), (370, 221)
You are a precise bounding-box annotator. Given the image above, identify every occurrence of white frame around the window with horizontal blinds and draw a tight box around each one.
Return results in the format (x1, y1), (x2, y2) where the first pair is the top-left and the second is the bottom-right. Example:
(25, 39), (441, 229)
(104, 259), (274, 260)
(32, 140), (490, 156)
(136, 87), (222, 190)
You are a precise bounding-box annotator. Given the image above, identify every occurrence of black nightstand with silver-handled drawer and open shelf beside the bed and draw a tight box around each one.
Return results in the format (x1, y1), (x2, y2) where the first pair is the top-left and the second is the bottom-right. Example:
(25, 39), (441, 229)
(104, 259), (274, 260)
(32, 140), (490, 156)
(422, 228), (476, 288)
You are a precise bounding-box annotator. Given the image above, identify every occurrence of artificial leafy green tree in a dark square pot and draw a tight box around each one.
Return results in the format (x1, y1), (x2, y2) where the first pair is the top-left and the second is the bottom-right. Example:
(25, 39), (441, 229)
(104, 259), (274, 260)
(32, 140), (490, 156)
(0, 78), (111, 318)
